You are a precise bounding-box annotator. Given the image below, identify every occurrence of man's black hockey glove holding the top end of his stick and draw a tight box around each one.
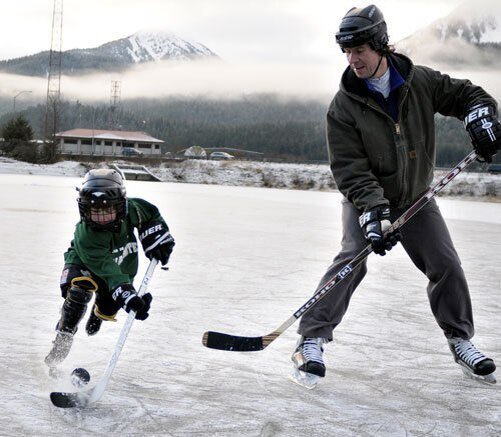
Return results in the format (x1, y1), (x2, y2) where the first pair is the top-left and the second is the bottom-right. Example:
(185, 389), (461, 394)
(464, 105), (501, 162)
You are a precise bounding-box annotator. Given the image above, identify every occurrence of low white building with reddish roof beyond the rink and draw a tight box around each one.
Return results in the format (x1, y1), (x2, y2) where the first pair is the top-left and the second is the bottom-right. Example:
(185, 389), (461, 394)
(55, 129), (163, 156)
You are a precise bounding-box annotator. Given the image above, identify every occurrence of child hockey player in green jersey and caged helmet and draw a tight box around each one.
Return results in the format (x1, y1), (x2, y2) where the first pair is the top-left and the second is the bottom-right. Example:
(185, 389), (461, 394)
(45, 169), (175, 372)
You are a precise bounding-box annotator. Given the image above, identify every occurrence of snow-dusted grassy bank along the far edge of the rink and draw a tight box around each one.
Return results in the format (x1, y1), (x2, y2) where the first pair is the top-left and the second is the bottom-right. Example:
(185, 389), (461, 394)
(0, 157), (501, 201)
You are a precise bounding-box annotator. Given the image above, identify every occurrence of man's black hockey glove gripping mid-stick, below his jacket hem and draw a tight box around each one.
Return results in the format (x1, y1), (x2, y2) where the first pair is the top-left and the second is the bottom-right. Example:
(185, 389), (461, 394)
(358, 206), (402, 255)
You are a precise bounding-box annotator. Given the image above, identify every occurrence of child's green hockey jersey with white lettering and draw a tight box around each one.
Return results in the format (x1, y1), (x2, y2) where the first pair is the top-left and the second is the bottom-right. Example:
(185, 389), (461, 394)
(64, 198), (167, 289)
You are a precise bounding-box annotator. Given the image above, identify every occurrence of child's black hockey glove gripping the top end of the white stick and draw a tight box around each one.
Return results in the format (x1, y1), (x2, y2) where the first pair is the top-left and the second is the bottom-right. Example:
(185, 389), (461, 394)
(139, 220), (176, 266)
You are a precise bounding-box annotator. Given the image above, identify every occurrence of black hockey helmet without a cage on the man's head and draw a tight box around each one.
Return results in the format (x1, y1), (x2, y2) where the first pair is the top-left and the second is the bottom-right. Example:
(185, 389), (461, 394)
(336, 5), (389, 52)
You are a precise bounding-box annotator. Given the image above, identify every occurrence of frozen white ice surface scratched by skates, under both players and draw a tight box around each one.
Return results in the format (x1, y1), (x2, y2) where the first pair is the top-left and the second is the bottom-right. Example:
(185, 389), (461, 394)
(0, 174), (501, 436)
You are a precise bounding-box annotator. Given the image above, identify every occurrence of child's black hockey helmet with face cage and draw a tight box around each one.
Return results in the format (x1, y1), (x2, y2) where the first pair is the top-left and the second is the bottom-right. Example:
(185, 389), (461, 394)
(77, 169), (127, 232)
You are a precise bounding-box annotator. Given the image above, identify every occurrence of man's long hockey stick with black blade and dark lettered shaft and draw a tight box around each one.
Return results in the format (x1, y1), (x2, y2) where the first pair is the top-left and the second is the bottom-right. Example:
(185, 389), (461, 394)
(202, 151), (477, 352)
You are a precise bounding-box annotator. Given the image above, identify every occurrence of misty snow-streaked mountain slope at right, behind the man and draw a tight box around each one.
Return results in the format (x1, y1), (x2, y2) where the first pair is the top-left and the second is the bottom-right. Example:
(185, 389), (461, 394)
(396, 0), (501, 69)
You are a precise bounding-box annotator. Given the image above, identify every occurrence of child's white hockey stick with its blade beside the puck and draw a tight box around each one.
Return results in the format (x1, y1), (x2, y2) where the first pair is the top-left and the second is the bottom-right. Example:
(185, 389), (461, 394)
(50, 259), (158, 408)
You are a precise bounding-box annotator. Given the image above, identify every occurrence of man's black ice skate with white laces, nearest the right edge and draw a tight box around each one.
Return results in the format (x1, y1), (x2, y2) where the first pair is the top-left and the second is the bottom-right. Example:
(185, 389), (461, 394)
(448, 338), (496, 384)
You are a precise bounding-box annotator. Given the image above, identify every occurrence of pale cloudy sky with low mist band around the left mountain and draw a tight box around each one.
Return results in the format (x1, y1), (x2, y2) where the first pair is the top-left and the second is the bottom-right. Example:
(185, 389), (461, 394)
(0, 0), (474, 99)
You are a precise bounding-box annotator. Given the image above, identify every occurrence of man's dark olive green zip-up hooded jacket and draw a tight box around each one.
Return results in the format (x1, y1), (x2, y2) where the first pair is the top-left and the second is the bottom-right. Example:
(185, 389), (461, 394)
(327, 53), (497, 211)
